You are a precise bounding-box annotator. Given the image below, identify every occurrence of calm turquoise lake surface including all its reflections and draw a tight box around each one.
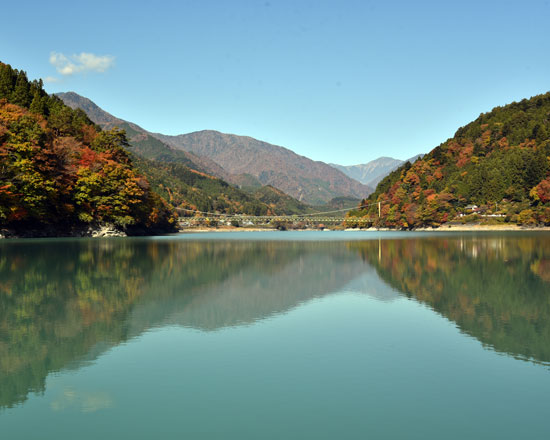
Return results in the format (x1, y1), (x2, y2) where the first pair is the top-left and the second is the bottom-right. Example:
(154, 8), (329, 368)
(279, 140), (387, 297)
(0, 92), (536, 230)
(0, 232), (550, 440)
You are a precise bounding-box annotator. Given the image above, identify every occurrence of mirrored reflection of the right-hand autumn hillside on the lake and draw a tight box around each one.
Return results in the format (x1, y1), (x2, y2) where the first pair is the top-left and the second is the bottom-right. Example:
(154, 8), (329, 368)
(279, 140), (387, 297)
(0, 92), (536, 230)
(350, 234), (550, 363)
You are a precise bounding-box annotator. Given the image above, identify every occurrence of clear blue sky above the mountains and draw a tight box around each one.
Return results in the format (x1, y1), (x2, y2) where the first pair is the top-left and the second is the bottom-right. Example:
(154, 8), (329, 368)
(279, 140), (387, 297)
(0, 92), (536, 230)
(0, 0), (550, 165)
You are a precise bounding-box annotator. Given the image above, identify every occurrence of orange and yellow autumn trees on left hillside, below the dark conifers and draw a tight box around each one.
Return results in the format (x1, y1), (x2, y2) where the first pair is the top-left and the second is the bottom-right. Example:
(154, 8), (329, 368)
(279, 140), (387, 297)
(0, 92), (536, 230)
(0, 100), (174, 230)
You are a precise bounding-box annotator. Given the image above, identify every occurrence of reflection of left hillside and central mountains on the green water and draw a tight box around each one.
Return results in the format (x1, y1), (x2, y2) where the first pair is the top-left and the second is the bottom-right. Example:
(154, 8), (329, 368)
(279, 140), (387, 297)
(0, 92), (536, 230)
(0, 240), (380, 406)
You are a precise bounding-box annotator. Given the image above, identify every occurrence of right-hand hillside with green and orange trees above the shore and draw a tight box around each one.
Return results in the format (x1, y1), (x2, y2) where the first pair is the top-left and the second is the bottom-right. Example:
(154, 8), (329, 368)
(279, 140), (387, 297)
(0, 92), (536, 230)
(350, 93), (550, 228)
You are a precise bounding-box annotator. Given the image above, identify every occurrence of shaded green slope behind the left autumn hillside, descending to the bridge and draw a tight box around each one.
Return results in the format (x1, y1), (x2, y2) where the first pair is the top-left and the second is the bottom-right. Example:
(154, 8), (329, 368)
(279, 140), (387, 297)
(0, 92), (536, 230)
(56, 92), (311, 215)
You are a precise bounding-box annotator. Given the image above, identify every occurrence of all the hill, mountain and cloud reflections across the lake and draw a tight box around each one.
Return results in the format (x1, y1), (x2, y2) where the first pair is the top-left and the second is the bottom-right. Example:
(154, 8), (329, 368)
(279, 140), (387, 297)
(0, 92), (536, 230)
(0, 235), (550, 412)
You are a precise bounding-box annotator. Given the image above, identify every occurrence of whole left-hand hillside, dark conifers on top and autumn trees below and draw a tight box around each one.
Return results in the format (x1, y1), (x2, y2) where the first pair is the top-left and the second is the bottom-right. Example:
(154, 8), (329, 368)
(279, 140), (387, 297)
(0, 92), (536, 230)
(0, 63), (175, 232)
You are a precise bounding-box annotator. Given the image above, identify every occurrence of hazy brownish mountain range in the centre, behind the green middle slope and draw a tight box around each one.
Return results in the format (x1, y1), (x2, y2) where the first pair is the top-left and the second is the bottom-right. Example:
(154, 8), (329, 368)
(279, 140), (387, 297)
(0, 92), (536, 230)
(57, 92), (373, 204)
